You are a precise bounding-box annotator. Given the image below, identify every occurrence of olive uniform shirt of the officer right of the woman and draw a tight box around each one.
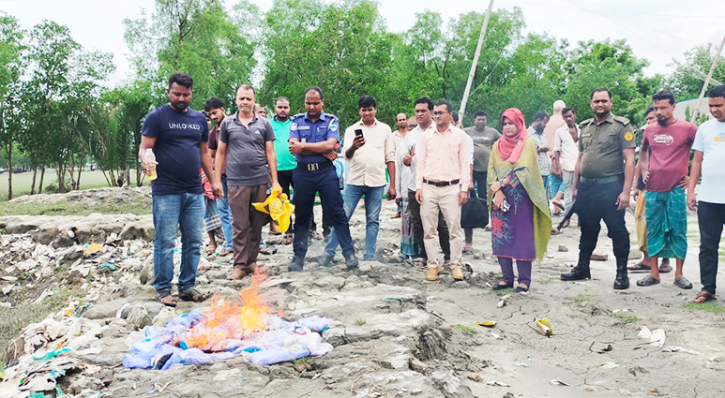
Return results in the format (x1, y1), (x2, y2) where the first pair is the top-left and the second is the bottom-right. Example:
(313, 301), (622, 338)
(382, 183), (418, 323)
(579, 113), (635, 178)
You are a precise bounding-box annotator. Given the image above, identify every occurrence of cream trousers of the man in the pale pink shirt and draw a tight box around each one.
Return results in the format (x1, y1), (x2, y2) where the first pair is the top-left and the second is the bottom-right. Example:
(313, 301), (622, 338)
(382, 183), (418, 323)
(420, 183), (463, 267)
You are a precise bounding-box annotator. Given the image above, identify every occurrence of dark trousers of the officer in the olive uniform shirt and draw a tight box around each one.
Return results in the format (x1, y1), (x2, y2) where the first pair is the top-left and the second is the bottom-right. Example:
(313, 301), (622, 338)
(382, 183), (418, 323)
(576, 181), (629, 266)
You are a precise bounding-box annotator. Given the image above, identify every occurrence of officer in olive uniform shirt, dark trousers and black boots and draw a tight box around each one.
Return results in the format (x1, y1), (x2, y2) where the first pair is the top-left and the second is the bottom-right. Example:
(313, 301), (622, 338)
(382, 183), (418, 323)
(561, 87), (635, 289)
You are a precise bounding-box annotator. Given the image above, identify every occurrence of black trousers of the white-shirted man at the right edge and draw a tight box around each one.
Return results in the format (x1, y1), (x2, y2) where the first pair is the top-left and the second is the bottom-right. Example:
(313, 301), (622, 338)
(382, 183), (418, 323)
(697, 201), (725, 294)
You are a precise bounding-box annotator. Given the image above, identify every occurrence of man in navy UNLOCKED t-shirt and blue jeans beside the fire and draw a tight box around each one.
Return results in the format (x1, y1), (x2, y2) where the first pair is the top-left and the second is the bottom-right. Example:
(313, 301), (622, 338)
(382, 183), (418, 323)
(138, 73), (214, 307)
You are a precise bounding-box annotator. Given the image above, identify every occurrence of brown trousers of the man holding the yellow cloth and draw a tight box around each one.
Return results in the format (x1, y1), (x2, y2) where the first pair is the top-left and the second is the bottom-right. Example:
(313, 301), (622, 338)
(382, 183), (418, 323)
(228, 184), (269, 270)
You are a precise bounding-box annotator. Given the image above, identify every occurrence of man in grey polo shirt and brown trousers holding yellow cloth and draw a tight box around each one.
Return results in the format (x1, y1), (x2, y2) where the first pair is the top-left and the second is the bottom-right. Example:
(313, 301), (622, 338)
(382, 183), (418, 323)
(214, 85), (282, 280)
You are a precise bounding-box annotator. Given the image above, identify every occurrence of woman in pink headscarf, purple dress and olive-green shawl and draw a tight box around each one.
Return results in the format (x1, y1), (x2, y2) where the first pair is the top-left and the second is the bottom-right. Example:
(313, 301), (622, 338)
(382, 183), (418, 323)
(488, 108), (551, 292)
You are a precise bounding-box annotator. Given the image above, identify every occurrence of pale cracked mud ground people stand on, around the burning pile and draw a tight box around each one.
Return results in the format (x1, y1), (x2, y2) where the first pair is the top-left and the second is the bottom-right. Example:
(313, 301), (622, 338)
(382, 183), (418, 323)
(0, 188), (725, 398)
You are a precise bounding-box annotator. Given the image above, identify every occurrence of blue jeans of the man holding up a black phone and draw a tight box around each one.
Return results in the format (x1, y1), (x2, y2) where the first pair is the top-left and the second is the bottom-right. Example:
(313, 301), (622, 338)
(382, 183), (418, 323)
(325, 185), (385, 260)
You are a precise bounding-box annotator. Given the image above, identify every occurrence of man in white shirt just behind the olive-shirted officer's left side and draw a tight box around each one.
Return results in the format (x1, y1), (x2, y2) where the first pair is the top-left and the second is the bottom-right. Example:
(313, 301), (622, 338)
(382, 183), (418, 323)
(549, 107), (579, 213)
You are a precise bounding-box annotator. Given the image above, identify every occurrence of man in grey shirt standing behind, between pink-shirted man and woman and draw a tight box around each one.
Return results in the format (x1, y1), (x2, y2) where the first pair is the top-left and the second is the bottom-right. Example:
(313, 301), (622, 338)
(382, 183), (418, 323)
(463, 111), (501, 253)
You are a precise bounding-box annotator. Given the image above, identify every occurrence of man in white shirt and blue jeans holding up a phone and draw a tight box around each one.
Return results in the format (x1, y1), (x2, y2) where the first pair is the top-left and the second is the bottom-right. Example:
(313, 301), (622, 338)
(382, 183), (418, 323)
(318, 95), (395, 267)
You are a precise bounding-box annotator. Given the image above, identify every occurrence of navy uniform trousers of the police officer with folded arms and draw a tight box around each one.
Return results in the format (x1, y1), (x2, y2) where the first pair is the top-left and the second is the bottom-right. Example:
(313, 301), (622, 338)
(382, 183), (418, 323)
(292, 167), (355, 259)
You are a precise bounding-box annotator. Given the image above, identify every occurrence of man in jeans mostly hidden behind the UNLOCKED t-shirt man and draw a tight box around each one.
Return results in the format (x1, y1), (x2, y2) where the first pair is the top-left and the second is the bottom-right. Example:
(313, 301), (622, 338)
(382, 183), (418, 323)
(204, 97), (234, 256)
